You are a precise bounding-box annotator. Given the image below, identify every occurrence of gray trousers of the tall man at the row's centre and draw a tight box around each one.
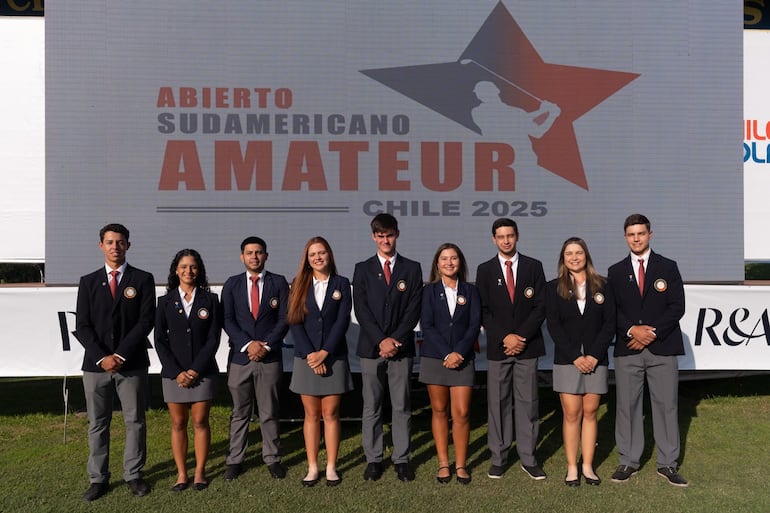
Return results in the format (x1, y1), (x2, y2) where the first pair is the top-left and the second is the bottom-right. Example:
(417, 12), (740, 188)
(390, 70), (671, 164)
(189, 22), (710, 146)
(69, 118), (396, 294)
(361, 357), (414, 463)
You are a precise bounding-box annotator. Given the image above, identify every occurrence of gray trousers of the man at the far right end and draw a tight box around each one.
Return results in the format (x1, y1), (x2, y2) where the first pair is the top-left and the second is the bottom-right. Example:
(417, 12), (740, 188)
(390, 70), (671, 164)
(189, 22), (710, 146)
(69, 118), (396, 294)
(615, 349), (679, 468)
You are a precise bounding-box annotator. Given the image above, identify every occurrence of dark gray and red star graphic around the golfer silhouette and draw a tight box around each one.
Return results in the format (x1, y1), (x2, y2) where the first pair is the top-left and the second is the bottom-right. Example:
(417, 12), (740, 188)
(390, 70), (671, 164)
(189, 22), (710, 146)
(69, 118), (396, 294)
(361, 2), (639, 190)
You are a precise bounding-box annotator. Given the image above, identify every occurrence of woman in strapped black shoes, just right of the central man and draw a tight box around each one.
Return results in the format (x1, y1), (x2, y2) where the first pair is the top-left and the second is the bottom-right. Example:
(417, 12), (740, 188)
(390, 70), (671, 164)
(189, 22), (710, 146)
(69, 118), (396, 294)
(420, 243), (481, 484)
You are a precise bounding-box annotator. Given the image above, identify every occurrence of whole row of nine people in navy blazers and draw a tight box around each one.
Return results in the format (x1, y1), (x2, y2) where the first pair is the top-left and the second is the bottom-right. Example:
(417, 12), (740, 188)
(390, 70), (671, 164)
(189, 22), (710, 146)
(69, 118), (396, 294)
(76, 213), (687, 501)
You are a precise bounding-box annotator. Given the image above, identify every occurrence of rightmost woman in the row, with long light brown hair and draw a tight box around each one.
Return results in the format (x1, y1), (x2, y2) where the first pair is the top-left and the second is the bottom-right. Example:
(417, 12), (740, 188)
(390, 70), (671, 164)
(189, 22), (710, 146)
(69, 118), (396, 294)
(546, 237), (615, 486)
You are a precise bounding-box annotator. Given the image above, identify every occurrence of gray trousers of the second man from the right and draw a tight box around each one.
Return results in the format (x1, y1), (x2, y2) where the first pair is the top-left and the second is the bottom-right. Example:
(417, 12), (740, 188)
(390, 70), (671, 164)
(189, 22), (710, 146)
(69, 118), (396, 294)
(487, 356), (540, 467)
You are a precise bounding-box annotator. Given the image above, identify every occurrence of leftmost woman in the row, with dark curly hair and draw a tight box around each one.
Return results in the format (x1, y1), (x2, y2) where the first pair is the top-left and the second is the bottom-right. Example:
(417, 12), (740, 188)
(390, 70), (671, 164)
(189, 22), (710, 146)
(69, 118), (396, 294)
(155, 249), (222, 492)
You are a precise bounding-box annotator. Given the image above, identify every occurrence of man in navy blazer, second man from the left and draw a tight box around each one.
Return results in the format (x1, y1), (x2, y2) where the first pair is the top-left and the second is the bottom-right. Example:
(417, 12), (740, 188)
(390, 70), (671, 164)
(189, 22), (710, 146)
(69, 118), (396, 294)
(222, 237), (289, 481)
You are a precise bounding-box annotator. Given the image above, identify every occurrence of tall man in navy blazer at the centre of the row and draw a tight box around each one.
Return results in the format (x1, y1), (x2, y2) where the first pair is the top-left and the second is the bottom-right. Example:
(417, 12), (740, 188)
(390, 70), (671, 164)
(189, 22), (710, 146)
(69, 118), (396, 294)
(353, 214), (422, 481)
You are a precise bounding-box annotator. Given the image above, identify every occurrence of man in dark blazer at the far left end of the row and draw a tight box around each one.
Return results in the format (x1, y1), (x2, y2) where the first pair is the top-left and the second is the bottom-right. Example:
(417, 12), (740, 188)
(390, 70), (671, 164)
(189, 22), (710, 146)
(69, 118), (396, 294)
(76, 224), (155, 502)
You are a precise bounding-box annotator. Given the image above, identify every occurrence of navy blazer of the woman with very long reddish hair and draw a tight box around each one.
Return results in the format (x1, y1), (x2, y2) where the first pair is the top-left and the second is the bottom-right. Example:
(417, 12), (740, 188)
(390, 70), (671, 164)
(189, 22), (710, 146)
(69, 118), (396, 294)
(289, 276), (353, 361)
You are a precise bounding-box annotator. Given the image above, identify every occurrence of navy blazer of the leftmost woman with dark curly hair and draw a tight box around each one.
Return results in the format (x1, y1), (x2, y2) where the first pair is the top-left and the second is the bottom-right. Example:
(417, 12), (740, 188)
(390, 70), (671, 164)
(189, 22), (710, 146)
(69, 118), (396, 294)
(155, 288), (222, 379)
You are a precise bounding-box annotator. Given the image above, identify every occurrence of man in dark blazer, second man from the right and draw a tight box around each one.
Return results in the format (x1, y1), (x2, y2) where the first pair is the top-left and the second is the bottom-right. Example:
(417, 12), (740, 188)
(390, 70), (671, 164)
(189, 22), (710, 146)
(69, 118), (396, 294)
(476, 218), (546, 480)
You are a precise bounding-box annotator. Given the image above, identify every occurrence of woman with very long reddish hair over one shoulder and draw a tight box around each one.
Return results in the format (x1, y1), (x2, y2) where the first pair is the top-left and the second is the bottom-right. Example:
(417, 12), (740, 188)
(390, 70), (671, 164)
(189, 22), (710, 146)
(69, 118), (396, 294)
(288, 237), (353, 487)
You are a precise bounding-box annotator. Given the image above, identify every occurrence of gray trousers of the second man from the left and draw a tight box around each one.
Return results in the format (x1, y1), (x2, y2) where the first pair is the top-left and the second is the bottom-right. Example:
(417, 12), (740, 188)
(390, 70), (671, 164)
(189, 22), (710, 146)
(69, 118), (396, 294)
(225, 361), (283, 465)
